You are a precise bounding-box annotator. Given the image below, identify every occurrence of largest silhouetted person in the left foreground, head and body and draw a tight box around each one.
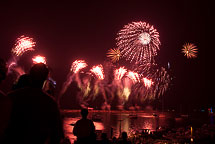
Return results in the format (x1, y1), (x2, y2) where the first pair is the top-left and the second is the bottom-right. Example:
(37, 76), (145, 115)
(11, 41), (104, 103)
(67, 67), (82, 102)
(4, 63), (64, 144)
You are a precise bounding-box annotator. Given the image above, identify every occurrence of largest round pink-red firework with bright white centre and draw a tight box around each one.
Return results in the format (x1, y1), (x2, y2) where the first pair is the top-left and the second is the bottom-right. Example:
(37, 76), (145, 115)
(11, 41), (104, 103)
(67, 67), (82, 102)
(116, 22), (160, 63)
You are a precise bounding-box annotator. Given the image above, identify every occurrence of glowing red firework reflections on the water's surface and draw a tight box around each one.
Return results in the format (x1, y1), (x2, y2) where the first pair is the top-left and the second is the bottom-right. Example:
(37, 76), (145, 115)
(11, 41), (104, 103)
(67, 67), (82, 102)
(64, 112), (172, 143)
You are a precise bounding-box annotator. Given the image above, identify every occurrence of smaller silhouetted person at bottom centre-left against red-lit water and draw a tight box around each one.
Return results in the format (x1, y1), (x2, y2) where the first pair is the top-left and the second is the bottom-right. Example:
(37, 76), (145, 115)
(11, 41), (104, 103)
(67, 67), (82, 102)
(73, 109), (95, 144)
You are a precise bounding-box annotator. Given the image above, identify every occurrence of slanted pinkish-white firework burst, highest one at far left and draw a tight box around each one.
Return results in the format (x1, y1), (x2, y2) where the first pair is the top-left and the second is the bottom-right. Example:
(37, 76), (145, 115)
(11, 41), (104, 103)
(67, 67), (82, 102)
(11, 35), (36, 56)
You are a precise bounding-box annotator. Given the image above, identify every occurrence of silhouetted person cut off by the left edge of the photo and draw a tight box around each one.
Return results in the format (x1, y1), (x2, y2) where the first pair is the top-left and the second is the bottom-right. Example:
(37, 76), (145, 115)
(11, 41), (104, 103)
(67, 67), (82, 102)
(0, 58), (12, 143)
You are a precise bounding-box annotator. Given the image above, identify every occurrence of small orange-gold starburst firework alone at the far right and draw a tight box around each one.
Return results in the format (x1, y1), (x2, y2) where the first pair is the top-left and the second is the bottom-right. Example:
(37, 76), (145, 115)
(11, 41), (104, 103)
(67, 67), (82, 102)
(182, 43), (198, 58)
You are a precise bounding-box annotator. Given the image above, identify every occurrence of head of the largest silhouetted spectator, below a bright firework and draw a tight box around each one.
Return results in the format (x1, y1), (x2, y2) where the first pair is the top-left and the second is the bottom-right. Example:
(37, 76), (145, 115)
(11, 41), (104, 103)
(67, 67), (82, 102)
(30, 63), (49, 88)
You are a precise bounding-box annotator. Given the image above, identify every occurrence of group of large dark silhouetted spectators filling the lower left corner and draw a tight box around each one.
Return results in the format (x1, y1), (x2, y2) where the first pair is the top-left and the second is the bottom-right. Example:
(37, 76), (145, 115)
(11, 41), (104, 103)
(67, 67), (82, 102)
(0, 60), (64, 144)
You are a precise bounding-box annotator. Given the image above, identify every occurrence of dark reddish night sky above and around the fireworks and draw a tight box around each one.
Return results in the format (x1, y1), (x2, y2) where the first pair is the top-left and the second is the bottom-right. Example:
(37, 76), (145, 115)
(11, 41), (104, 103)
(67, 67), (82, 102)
(0, 0), (208, 106)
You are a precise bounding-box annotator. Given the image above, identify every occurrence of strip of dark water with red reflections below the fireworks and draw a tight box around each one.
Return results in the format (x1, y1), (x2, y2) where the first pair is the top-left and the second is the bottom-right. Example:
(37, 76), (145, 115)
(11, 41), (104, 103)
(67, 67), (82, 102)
(64, 111), (212, 143)
